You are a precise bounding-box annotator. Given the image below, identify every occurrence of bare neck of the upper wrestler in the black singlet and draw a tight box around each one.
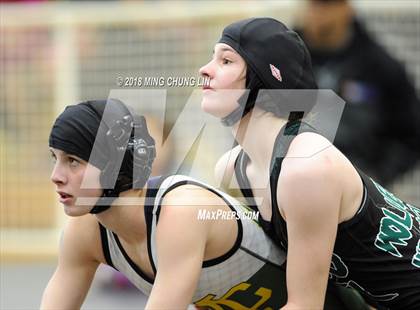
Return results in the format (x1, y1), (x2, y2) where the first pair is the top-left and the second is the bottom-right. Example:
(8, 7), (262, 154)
(232, 107), (287, 171)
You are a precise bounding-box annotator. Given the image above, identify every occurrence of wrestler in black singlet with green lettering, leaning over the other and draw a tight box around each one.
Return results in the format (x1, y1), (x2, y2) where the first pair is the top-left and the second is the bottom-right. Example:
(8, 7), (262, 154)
(200, 18), (420, 309)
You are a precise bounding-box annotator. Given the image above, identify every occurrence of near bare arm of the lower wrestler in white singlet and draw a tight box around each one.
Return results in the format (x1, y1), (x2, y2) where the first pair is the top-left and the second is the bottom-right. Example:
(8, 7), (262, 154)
(146, 186), (210, 309)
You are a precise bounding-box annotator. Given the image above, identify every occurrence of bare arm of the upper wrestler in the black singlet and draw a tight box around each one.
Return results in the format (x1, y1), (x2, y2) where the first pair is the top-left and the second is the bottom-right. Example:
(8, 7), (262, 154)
(277, 145), (342, 310)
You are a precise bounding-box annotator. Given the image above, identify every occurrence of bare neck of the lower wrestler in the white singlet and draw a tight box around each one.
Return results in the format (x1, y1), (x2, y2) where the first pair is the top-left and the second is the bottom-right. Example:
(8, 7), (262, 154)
(95, 188), (146, 244)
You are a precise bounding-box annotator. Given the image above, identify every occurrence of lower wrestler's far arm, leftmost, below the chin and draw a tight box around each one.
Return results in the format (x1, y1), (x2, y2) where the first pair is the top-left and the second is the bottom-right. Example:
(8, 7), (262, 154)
(40, 215), (102, 310)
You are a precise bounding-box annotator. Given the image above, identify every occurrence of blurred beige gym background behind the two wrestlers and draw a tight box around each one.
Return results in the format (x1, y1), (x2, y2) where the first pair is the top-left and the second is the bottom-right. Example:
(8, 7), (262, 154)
(0, 0), (420, 309)
